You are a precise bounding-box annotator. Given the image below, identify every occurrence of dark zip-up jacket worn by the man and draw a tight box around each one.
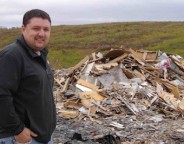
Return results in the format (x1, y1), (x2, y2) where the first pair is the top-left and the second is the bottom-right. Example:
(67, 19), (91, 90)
(0, 35), (56, 143)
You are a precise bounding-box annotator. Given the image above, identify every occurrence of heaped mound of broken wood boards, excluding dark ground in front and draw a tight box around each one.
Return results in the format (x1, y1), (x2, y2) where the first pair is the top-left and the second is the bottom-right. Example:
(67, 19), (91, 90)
(54, 49), (184, 143)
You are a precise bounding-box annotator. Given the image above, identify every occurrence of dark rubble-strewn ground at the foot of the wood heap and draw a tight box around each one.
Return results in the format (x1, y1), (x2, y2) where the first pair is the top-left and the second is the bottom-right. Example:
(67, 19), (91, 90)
(53, 111), (184, 144)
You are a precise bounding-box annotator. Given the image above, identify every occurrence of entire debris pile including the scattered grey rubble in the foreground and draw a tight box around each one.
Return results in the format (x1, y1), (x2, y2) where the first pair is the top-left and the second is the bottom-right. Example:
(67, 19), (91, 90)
(54, 49), (184, 144)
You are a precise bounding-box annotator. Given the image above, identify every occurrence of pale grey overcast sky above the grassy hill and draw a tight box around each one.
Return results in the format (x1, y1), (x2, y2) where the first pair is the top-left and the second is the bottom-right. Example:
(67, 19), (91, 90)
(0, 0), (184, 27)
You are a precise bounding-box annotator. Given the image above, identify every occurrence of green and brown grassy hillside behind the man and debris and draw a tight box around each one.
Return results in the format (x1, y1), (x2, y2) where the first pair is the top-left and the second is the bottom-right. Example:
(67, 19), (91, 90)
(0, 22), (184, 69)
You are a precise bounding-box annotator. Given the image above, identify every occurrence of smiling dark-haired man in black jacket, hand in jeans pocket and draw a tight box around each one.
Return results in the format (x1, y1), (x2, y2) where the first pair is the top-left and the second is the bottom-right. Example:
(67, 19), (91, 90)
(0, 9), (56, 144)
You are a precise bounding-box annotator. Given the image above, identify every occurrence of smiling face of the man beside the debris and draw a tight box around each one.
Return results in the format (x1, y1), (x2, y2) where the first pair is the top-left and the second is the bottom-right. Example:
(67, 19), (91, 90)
(22, 17), (51, 51)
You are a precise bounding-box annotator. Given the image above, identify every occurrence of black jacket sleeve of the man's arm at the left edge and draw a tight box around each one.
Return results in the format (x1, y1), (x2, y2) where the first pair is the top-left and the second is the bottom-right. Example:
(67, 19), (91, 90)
(0, 51), (24, 135)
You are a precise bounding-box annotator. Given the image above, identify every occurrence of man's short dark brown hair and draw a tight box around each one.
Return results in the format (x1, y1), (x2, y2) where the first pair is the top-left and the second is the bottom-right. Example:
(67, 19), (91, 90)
(22, 9), (51, 26)
